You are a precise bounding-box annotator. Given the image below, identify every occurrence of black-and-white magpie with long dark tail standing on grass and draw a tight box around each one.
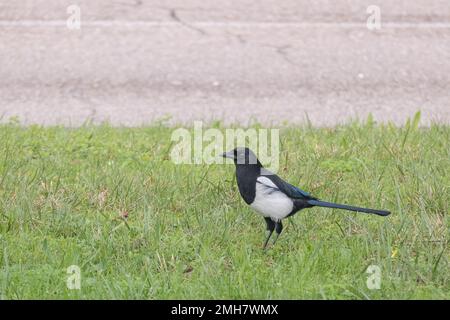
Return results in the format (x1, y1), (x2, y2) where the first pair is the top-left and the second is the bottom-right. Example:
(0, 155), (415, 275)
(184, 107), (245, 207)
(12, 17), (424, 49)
(222, 147), (391, 250)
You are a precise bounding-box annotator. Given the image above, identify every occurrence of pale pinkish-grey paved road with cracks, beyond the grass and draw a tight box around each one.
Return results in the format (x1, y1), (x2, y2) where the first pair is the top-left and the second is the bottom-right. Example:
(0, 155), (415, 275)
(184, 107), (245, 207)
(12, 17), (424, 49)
(0, 0), (450, 126)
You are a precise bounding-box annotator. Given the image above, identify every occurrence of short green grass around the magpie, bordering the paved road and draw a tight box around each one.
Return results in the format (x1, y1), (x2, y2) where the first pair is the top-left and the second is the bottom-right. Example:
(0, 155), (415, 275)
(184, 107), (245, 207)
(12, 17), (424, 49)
(0, 121), (450, 299)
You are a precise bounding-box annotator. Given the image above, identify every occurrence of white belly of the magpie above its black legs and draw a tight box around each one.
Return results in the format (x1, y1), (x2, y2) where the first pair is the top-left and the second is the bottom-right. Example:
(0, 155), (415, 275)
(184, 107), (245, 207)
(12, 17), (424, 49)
(250, 183), (294, 221)
